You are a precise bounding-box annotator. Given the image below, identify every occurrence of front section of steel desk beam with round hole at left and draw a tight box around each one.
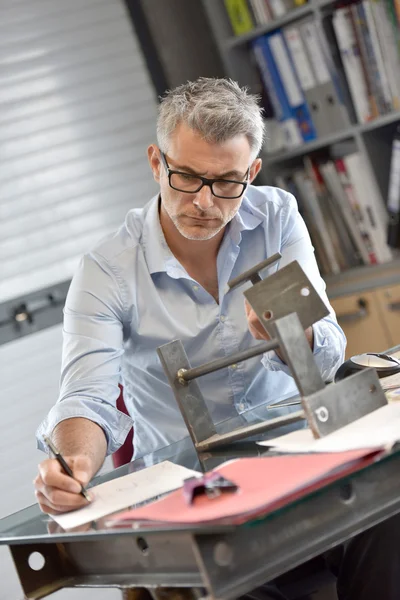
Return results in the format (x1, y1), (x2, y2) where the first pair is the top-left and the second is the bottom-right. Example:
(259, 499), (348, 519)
(10, 532), (203, 599)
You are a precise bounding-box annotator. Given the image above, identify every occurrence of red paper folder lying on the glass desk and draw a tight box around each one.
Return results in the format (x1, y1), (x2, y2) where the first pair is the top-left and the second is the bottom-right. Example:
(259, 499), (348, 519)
(109, 448), (383, 525)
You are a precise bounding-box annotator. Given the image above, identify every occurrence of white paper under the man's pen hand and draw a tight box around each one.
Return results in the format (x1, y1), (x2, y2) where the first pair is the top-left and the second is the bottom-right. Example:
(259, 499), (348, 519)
(52, 461), (201, 530)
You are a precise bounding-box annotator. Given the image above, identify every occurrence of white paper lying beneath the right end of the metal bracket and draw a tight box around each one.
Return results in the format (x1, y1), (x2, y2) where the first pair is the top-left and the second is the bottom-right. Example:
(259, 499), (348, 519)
(258, 403), (400, 453)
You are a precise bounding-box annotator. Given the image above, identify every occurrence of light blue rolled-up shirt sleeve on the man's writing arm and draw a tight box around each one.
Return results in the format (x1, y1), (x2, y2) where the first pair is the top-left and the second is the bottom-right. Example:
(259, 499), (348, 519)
(37, 253), (132, 454)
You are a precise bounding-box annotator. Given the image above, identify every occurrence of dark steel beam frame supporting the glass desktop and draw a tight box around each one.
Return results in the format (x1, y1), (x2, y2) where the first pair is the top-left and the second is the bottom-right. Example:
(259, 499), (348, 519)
(0, 451), (400, 599)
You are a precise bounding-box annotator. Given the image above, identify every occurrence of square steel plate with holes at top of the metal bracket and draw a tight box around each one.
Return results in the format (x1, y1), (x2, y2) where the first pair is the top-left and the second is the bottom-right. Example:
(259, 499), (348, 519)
(244, 261), (329, 337)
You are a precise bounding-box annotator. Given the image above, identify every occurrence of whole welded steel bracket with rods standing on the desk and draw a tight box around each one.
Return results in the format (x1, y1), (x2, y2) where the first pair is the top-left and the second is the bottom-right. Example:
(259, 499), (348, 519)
(157, 254), (387, 452)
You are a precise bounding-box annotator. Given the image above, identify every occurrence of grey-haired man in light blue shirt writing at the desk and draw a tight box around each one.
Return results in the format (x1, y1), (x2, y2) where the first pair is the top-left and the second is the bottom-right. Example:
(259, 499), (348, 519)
(35, 78), (400, 600)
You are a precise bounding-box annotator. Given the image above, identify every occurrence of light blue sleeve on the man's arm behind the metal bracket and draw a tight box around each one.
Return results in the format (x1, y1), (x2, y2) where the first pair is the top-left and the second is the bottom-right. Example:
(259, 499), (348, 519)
(262, 194), (346, 381)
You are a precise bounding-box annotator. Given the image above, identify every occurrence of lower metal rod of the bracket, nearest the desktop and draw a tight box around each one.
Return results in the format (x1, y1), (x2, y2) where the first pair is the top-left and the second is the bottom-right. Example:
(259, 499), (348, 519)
(196, 410), (306, 452)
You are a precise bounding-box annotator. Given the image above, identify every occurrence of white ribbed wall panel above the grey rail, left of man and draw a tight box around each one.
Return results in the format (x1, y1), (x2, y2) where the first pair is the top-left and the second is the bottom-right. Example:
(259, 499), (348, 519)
(0, 0), (156, 302)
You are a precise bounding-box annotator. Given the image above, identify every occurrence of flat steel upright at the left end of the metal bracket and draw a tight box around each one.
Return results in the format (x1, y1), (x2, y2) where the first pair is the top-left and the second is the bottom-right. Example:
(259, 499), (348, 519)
(157, 340), (217, 445)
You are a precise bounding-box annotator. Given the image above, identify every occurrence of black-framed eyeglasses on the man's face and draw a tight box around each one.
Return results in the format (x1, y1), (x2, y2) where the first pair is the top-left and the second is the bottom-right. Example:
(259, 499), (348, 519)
(160, 151), (250, 200)
